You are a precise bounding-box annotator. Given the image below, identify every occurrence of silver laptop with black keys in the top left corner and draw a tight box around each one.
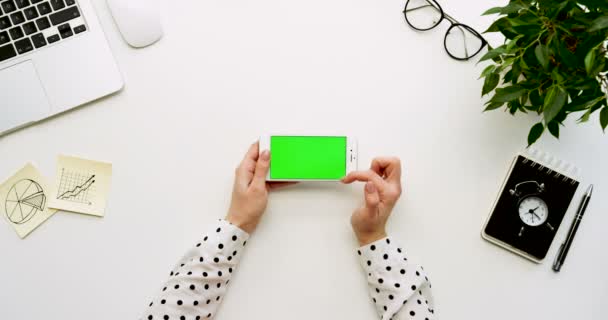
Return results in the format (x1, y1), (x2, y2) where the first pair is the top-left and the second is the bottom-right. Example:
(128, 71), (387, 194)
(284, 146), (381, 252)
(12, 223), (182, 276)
(0, 0), (123, 135)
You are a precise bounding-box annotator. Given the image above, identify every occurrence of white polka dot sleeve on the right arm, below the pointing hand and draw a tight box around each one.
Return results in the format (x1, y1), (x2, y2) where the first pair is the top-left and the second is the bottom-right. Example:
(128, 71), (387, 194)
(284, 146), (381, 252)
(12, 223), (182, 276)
(357, 238), (435, 320)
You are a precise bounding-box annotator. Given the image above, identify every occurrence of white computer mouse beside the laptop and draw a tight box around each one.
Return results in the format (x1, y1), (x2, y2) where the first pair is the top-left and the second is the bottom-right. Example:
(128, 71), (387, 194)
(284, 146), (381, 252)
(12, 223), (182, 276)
(107, 0), (163, 48)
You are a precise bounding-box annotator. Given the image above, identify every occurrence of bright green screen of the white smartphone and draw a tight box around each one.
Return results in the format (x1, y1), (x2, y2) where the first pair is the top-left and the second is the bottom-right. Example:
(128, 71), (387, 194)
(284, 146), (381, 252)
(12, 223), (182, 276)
(270, 136), (346, 180)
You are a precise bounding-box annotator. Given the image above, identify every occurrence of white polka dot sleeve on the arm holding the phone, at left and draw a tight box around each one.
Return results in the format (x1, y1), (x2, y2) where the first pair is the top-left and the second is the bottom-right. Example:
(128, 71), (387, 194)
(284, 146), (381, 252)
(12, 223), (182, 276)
(140, 220), (249, 320)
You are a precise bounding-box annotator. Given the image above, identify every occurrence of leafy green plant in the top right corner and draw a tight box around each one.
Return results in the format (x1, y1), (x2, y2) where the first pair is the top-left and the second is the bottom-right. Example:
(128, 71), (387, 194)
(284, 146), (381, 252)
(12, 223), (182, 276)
(480, 0), (608, 145)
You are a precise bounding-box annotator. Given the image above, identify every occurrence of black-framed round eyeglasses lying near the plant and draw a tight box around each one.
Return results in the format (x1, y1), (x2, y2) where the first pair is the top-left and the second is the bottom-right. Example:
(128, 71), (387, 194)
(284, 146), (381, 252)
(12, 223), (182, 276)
(403, 0), (488, 60)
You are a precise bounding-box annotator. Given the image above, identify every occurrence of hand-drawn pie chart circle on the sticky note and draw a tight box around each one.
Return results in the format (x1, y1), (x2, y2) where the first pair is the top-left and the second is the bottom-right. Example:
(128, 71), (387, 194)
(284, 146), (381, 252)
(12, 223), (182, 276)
(5, 179), (46, 224)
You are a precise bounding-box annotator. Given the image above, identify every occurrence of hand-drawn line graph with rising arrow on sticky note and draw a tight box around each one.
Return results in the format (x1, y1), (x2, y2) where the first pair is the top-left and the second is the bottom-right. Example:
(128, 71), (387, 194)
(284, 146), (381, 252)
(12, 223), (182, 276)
(57, 168), (95, 205)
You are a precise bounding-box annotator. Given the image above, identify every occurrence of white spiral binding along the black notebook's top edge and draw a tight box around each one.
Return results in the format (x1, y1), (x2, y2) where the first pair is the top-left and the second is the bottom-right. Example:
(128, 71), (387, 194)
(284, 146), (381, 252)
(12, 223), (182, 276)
(521, 148), (581, 185)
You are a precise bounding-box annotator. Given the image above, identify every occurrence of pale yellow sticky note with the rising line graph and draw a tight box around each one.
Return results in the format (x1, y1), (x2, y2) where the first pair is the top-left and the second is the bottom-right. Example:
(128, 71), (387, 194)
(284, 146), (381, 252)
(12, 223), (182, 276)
(49, 156), (112, 217)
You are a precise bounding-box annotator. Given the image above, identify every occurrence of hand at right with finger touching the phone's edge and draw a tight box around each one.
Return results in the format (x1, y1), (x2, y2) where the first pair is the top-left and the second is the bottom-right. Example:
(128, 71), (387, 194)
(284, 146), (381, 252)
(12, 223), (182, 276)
(342, 157), (401, 246)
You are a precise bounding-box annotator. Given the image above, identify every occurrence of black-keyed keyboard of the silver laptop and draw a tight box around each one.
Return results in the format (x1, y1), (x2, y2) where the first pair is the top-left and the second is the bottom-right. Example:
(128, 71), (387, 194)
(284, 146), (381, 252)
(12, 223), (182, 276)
(0, 0), (87, 62)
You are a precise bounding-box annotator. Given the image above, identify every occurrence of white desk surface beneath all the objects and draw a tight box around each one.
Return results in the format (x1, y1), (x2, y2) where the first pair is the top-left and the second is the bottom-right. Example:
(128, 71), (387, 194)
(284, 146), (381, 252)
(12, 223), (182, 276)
(0, 0), (608, 320)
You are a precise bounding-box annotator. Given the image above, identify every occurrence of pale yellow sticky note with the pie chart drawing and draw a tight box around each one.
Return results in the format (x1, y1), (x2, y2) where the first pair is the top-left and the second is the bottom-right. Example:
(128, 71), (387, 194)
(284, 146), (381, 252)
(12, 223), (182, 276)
(0, 163), (57, 238)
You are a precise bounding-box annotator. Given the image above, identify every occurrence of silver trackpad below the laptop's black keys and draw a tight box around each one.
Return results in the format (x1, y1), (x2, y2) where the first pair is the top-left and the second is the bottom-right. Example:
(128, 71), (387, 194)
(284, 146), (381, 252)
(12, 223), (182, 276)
(0, 61), (51, 132)
